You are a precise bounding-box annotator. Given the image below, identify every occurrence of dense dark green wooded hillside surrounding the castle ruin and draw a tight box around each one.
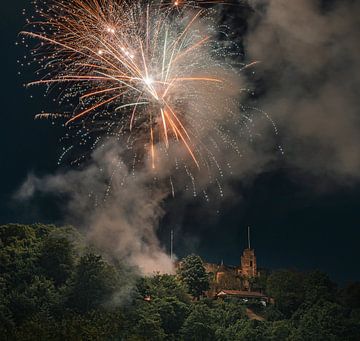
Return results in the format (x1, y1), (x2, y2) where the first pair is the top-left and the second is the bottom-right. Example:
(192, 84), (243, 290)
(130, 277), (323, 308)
(0, 224), (360, 341)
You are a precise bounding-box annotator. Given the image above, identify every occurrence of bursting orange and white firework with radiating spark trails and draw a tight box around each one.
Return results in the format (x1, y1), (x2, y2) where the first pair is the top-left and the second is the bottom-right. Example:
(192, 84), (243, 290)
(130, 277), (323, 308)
(21, 0), (278, 192)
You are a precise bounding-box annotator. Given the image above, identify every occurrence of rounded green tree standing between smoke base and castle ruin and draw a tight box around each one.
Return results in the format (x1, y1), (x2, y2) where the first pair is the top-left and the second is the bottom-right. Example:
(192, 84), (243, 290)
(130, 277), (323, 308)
(178, 255), (209, 299)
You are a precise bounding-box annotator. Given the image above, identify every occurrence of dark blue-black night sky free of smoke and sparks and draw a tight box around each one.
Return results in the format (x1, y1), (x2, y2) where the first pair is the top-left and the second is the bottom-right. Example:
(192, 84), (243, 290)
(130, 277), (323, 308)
(0, 0), (360, 283)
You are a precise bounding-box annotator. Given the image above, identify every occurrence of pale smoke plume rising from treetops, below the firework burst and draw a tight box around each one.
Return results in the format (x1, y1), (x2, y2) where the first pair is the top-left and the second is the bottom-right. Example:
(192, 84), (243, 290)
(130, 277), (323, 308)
(17, 143), (173, 275)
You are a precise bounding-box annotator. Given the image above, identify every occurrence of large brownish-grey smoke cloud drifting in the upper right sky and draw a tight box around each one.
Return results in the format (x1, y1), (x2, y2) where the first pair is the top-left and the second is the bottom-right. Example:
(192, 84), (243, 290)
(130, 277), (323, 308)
(246, 0), (360, 184)
